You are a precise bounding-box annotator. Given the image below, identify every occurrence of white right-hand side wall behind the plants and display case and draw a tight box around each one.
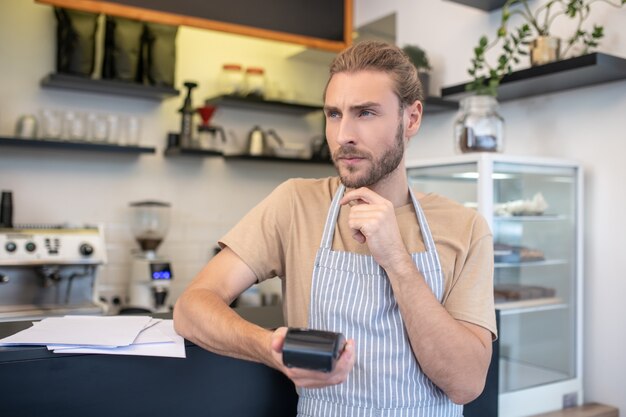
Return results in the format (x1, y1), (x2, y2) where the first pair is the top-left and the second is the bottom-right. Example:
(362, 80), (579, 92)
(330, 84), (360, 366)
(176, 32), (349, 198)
(355, 0), (626, 413)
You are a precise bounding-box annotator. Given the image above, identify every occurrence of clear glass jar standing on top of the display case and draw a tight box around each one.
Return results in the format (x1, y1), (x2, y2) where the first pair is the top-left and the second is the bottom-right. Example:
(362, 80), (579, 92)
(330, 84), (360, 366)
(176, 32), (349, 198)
(454, 95), (504, 153)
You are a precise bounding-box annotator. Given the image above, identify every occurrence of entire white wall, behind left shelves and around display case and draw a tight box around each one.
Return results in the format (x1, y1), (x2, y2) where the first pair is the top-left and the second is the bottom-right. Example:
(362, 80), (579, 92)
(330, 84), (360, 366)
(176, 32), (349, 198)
(0, 0), (626, 413)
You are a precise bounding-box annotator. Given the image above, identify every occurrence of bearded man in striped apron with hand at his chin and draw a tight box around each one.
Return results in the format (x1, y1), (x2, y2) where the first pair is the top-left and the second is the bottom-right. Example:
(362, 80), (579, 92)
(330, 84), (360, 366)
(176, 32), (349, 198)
(174, 42), (496, 416)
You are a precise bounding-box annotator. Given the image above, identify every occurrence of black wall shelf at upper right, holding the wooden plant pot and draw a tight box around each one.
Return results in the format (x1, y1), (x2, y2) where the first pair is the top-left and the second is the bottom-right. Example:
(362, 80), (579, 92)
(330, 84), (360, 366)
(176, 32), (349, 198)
(441, 52), (626, 102)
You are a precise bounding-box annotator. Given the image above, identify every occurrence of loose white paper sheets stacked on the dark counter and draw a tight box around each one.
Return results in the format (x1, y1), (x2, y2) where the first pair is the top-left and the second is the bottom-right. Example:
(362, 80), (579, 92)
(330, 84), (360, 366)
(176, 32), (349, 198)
(0, 316), (185, 358)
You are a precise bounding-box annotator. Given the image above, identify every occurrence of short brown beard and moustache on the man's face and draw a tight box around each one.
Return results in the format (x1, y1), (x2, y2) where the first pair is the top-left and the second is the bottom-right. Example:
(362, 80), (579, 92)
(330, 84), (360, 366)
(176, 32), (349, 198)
(333, 121), (404, 188)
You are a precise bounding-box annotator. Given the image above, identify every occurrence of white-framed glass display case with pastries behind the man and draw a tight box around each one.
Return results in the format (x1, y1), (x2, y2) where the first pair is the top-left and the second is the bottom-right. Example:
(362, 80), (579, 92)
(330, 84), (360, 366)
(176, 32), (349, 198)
(407, 153), (582, 417)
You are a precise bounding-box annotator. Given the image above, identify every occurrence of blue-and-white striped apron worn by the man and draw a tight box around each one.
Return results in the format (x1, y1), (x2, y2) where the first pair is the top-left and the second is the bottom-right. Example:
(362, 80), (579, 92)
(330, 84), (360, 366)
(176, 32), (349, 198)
(298, 185), (463, 417)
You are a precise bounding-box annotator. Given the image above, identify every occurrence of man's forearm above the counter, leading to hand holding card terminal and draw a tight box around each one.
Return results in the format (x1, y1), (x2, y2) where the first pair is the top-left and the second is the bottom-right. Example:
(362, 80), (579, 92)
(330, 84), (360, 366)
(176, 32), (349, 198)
(174, 289), (275, 367)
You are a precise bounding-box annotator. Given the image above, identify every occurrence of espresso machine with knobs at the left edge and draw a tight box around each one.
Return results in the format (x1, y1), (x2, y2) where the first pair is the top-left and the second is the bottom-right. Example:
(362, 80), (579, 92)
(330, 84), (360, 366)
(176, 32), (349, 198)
(0, 225), (106, 321)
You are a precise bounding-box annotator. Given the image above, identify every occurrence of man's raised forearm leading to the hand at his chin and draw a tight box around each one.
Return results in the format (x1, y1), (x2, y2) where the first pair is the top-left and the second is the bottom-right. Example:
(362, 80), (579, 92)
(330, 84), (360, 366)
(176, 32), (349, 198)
(387, 254), (491, 403)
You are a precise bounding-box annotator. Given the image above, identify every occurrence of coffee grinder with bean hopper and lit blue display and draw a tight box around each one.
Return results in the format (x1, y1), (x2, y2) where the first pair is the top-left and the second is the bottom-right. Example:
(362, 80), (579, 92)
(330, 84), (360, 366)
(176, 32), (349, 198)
(121, 201), (173, 313)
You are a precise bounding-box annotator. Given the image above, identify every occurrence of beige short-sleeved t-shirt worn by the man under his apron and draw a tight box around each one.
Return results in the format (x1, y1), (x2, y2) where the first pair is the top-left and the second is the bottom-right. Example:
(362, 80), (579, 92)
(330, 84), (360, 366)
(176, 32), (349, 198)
(220, 177), (496, 337)
